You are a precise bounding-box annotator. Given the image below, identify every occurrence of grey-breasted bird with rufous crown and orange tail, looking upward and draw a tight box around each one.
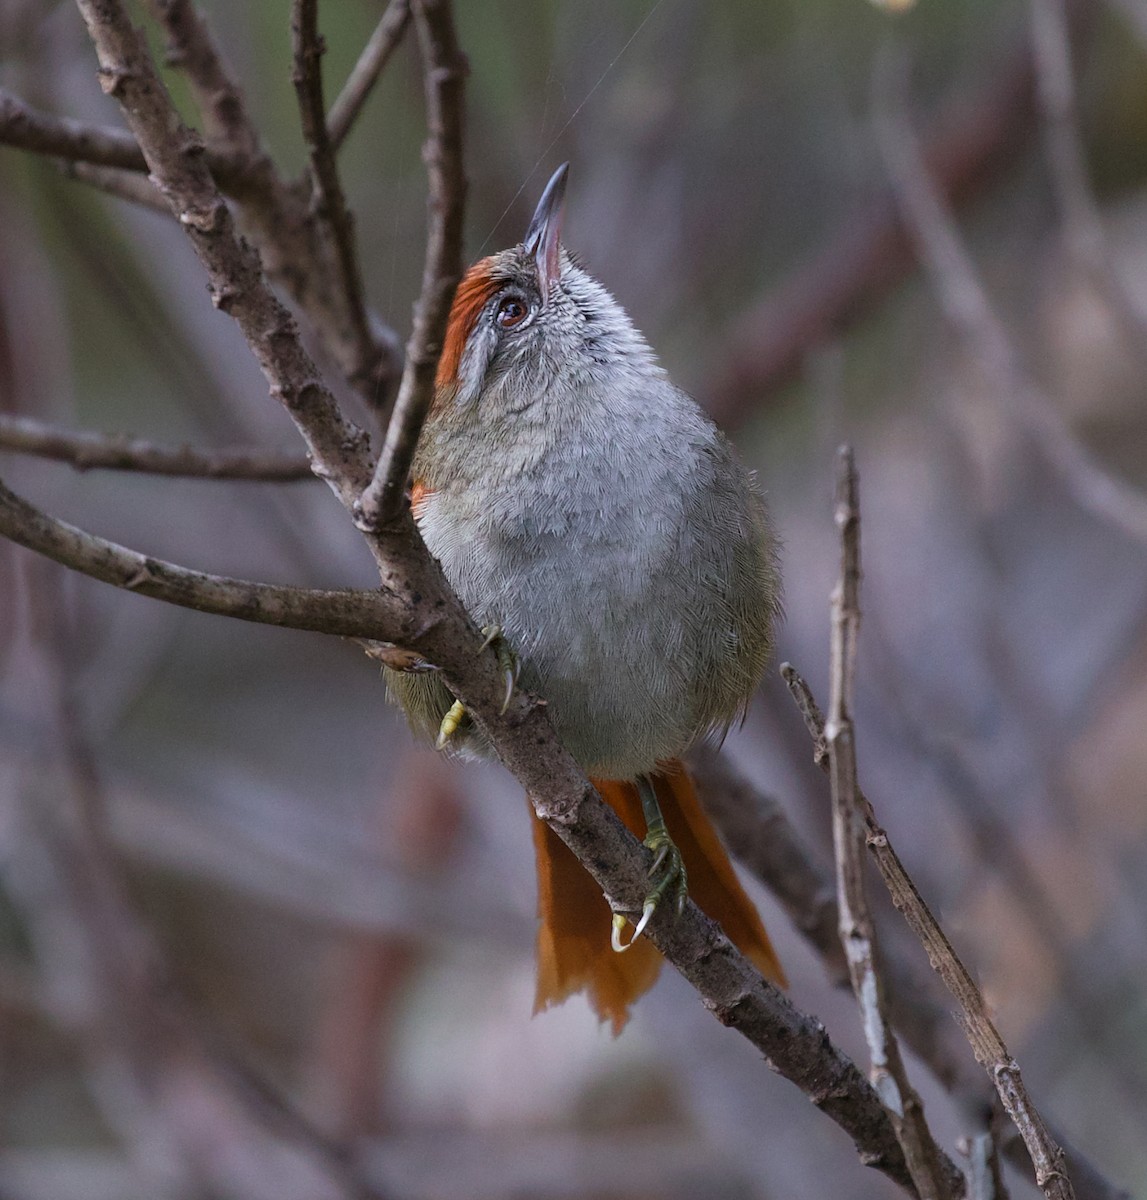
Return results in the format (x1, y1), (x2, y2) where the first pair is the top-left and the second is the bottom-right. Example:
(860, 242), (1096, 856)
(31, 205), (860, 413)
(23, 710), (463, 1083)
(386, 163), (785, 1034)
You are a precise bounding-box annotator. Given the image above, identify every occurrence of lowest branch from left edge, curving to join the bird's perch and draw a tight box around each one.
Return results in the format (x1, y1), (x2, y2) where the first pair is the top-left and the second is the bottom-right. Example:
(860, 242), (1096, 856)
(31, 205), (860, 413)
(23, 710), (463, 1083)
(0, 482), (409, 641)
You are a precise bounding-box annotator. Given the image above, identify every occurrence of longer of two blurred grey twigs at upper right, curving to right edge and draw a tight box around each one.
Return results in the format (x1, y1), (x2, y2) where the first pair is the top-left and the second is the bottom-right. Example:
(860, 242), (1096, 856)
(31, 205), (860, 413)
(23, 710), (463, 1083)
(873, 49), (1147, 542)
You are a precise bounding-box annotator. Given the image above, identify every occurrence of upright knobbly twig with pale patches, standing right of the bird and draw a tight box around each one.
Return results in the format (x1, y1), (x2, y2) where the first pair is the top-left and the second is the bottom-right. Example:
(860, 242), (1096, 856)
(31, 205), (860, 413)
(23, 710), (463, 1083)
(824, 446), (949, 1200)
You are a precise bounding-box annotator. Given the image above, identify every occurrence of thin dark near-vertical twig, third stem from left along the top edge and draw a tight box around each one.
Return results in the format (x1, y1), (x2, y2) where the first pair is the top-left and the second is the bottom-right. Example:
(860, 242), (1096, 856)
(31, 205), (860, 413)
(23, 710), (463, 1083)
(290, 0), (372, 388)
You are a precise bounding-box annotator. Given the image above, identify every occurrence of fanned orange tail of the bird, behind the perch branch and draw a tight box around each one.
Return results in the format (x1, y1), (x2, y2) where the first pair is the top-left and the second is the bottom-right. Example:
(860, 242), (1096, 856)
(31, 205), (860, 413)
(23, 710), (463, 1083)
(534, 760), (786, 1036)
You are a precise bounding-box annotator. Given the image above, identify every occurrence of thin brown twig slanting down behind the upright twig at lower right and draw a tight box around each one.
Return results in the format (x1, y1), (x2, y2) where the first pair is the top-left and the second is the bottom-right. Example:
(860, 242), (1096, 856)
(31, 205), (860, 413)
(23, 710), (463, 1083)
(783, 664), (1075, 1200)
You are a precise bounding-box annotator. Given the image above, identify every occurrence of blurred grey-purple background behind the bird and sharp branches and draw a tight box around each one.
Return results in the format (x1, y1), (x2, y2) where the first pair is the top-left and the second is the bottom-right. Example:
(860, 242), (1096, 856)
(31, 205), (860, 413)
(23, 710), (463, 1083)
(0, 0), (1147, 1200)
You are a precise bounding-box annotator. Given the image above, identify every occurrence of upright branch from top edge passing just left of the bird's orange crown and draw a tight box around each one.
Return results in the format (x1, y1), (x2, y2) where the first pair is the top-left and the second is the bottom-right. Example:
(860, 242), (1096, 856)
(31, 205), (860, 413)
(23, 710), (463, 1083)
(359, 0), (468, 529)
